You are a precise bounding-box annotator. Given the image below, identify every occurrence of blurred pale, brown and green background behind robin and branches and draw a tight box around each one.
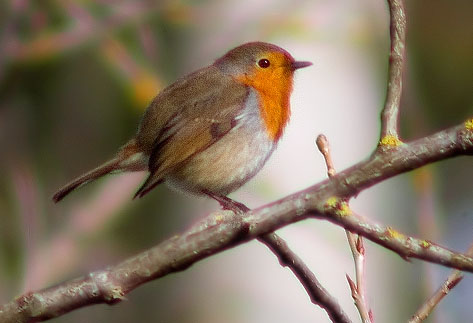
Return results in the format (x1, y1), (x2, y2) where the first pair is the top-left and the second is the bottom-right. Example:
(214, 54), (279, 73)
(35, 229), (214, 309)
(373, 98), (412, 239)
(0, 0), (473, 323)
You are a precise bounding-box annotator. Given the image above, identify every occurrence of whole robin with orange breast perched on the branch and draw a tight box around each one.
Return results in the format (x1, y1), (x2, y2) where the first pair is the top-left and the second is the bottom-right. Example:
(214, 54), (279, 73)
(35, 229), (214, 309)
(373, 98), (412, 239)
(53, 42), (312, 209)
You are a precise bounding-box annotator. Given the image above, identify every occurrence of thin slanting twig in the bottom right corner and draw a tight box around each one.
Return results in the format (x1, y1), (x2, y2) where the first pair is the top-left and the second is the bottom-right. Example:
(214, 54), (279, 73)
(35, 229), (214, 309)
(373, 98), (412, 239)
(409, 243), (473, 323)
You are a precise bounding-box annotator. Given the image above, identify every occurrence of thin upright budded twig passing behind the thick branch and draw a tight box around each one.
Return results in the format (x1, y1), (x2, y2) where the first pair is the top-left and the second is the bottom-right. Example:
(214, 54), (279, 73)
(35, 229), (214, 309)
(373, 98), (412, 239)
(316, 134), (373, 323)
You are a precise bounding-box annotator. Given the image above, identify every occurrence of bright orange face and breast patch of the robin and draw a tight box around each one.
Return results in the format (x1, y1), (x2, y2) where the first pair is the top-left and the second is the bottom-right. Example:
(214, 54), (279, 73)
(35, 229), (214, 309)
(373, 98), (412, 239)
(237, 67), (292, 141)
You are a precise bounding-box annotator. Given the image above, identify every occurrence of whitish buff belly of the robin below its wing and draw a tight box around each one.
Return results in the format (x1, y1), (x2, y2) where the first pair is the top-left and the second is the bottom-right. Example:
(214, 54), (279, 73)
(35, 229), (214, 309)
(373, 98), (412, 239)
(166, 92), (276, 195)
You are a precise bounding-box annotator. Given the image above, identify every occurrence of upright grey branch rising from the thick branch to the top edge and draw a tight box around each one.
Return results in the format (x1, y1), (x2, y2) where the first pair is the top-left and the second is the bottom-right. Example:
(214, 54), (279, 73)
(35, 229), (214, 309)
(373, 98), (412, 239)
(380, 0), (406, 145)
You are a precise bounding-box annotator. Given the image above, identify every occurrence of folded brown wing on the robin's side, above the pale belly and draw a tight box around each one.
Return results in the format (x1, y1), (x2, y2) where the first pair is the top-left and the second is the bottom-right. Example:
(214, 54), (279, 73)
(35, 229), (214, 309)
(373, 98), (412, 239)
(135, 67), (248, 197)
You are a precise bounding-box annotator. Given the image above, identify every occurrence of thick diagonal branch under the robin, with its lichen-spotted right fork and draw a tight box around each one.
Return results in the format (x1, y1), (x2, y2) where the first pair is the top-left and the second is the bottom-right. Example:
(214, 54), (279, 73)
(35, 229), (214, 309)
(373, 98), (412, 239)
(0, 119), (473, 322)
